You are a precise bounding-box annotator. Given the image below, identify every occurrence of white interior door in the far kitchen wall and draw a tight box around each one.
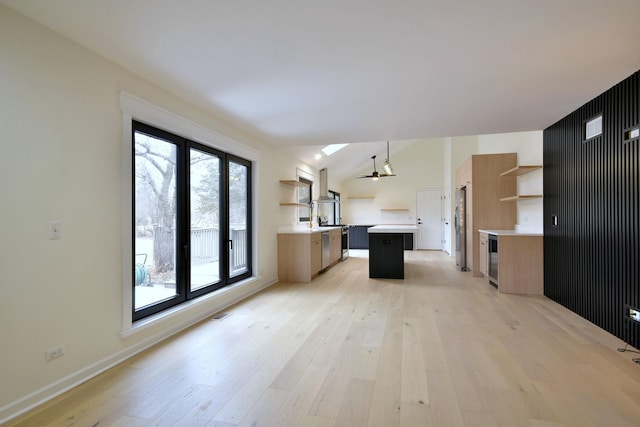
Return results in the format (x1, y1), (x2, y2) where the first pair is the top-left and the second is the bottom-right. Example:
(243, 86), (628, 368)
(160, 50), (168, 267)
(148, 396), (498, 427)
(416, 190), (442, 250)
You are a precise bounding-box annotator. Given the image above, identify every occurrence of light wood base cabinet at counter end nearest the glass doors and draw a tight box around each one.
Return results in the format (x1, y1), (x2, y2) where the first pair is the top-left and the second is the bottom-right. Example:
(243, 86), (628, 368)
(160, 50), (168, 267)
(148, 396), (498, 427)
(278, 233), (322, 283)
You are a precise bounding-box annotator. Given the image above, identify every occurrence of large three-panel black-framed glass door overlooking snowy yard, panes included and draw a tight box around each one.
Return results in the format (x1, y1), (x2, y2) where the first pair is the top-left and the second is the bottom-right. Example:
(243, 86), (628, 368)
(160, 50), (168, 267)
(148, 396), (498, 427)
(132, 122), (251, 320)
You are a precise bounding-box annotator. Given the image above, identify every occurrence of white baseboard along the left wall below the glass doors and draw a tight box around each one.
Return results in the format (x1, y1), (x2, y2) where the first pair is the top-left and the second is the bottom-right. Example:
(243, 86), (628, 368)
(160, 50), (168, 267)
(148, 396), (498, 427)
(0, 279), (278, 425)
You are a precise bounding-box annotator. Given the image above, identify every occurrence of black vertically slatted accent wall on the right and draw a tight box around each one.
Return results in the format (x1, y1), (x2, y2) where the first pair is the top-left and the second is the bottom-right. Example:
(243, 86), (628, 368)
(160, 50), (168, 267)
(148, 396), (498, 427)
(544, 72), (640, 348)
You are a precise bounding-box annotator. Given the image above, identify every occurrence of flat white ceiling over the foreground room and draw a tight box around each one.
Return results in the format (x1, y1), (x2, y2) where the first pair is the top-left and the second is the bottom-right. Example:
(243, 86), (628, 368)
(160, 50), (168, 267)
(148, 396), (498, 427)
(5, 0), (640, 179)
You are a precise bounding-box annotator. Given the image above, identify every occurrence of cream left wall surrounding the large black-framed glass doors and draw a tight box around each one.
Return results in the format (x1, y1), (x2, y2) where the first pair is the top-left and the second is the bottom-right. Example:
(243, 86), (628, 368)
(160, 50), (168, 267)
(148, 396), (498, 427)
(0, 6), (296, 423)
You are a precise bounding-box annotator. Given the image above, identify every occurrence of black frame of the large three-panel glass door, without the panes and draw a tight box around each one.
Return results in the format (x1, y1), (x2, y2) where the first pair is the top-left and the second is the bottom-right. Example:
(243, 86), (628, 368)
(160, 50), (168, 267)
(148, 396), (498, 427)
(130, 120), (253, 322)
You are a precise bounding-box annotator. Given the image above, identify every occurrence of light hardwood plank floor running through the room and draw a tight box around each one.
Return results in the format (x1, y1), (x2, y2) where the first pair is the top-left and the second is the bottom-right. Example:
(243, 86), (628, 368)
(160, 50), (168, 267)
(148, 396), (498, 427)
(9, 251), (640, 427)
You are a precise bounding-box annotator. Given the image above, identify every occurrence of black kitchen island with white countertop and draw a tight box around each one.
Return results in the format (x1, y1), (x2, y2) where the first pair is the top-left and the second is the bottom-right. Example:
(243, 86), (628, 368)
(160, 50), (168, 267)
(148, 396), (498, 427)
(367, 225), (418, 279)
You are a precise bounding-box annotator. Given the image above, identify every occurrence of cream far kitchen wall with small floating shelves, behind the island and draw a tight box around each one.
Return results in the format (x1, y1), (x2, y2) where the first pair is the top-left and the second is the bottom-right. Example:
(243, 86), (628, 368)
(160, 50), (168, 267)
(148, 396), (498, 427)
(341, 139), (444, 225)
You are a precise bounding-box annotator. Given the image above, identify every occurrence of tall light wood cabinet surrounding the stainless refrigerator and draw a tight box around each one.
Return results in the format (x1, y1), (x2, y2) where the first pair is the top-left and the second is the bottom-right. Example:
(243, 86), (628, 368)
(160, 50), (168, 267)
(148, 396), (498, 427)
(456, 153), (518, 277)
